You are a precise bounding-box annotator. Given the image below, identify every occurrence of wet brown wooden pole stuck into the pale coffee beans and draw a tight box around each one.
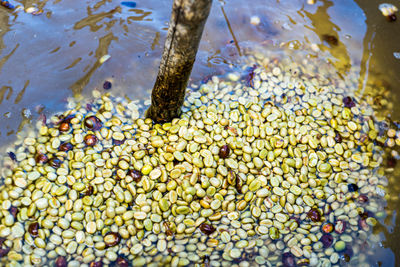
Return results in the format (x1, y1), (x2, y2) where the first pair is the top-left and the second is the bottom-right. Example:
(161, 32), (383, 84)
(146, 0), (212, 122)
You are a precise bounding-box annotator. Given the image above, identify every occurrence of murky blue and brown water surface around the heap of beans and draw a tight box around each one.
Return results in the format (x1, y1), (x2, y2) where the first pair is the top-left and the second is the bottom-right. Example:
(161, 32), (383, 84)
(0, 0), (400, 266)
